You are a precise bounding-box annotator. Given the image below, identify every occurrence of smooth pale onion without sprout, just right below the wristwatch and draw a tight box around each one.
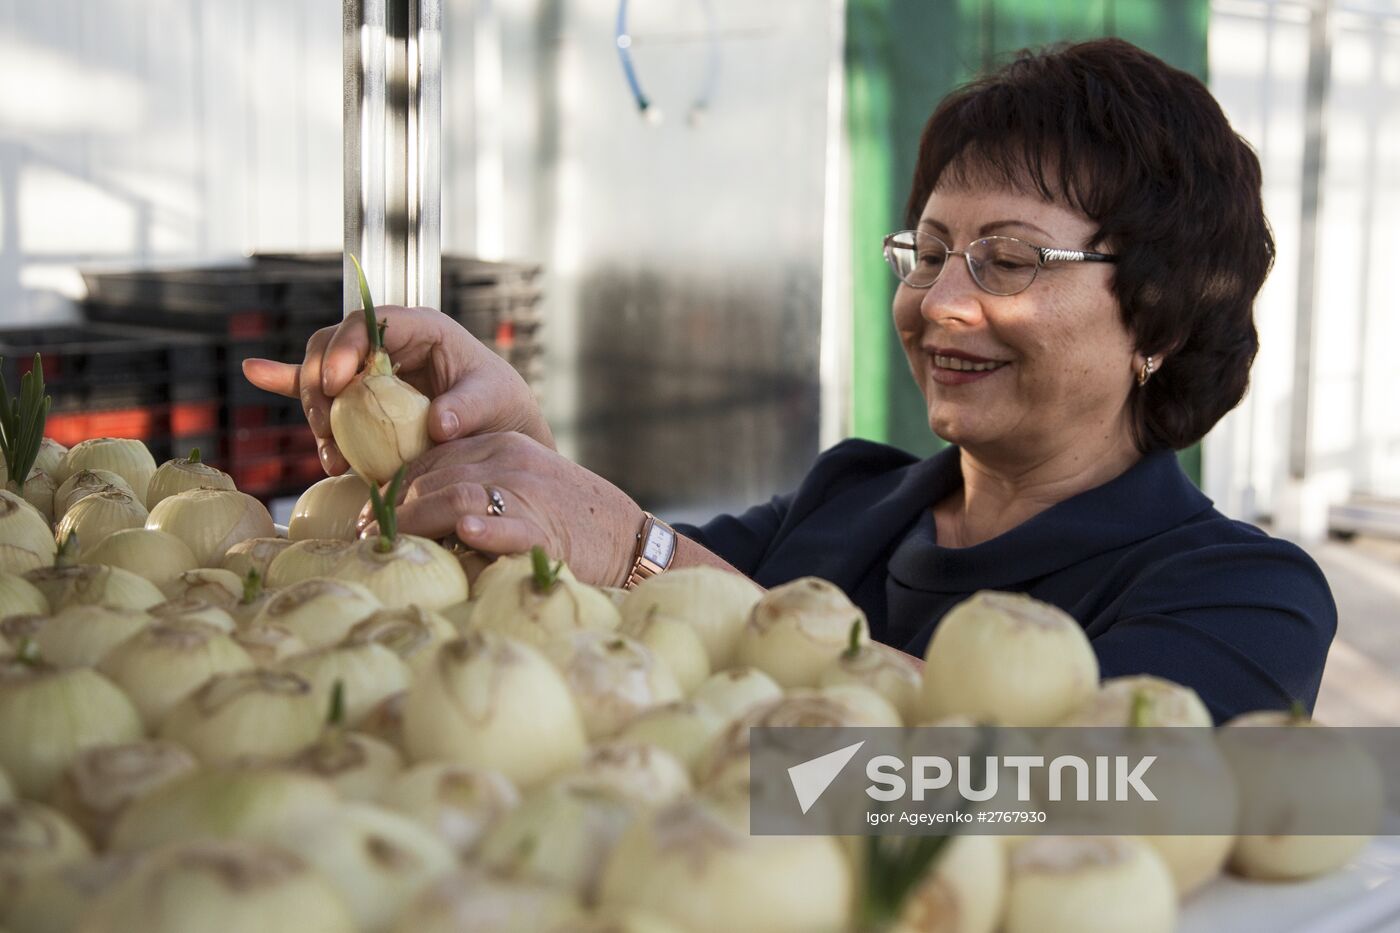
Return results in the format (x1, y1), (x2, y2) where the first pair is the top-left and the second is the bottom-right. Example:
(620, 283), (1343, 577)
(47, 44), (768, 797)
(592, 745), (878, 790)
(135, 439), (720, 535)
(622, 567), (761, 671)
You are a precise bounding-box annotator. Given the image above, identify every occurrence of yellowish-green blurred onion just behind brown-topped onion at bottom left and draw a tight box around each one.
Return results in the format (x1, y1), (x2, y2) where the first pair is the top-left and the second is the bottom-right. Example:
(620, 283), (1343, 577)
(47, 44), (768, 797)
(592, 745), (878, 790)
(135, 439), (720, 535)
(109, 768), (342, 852)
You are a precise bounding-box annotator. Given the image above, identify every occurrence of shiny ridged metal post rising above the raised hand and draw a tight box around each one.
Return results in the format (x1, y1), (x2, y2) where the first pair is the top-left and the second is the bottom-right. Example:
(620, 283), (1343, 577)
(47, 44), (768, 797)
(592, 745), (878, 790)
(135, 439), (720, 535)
(343, 0), (442, 311)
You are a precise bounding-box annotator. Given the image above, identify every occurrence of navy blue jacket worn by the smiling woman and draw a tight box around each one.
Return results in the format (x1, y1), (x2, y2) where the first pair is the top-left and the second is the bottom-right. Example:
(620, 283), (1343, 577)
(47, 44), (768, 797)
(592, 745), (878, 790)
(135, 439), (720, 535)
(678, 440), (1337, 721)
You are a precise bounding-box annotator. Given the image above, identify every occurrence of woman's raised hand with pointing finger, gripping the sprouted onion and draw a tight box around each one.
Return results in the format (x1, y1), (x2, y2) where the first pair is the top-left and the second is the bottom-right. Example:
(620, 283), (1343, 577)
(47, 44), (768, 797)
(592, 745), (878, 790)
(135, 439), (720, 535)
(244, 307), (554, 475)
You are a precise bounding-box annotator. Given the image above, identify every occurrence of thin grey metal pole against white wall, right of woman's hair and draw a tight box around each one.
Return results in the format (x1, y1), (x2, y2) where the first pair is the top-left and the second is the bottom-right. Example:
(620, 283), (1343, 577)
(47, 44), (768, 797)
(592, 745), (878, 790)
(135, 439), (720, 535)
(1288, 0), (1331, 479)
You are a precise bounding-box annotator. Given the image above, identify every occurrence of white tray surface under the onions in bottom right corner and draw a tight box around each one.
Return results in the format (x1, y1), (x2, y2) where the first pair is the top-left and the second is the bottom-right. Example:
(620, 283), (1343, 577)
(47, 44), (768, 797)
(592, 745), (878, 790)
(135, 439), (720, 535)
(1176, 835), (1400, 933)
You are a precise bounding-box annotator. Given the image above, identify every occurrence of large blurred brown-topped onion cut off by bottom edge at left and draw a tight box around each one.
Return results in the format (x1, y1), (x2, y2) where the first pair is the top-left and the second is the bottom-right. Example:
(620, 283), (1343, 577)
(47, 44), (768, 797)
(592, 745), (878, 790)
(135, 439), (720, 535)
(78, 839), (356, 933)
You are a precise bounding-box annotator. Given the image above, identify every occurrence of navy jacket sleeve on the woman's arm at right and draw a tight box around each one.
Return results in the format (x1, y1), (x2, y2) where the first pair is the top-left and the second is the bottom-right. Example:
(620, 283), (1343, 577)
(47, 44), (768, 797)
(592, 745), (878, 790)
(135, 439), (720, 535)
(1092, 538), (1337, 723)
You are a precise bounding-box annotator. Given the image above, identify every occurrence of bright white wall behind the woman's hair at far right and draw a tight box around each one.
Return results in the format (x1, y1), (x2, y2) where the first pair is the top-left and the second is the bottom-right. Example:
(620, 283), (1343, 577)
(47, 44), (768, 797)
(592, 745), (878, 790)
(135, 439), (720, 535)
(1205, 0), (1400, 537)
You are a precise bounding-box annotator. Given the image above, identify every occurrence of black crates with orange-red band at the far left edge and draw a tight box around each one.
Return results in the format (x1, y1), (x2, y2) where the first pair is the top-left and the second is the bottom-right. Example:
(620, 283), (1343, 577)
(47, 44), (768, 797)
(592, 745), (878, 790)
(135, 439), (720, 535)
(0, 325), (221, 462)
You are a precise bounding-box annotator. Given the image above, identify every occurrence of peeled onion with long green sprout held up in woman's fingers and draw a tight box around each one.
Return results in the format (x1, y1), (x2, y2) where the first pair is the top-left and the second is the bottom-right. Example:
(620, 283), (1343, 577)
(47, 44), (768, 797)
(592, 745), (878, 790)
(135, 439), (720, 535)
(330, 257), (437, 481)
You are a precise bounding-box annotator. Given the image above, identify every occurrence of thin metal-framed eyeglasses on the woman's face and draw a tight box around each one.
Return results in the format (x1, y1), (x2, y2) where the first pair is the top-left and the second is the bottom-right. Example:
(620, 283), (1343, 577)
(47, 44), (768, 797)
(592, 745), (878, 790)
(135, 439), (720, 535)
(885, 230), (1117, 296)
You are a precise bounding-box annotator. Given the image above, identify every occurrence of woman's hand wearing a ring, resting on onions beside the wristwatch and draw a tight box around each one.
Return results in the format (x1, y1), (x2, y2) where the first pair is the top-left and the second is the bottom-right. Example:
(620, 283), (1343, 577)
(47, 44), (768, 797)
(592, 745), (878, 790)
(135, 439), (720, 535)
(365, 433), (644, 586)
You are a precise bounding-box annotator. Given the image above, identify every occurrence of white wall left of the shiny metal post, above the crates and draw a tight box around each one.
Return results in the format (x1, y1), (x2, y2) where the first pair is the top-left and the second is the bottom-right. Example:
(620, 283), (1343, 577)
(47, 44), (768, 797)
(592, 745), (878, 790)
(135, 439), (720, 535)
(0, 0), (342, 325)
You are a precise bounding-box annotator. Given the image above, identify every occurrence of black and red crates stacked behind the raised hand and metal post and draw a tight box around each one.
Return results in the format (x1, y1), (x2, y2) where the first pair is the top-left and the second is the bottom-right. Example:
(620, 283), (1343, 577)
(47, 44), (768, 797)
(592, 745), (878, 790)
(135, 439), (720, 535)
(76, 254), (543, 502)
